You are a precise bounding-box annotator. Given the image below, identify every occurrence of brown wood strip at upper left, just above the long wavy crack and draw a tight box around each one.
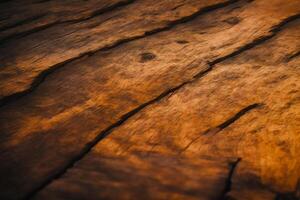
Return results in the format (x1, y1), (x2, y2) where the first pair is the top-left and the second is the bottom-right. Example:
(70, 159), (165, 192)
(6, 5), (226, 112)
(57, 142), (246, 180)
(0, 0), (232, 99)
